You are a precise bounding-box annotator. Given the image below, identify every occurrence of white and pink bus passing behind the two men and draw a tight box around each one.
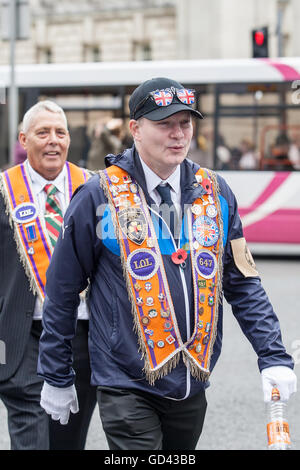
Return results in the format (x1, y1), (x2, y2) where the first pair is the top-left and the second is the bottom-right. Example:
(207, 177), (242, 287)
(0, 57), (300, 255)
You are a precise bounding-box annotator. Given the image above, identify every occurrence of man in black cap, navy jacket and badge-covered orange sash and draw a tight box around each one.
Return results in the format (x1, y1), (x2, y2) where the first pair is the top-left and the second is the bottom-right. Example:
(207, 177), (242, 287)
(39, 78), (296, 450)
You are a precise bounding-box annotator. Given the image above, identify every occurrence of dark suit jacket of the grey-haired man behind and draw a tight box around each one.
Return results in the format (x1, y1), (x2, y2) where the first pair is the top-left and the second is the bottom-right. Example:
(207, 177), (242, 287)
(0, 194), (35, 382)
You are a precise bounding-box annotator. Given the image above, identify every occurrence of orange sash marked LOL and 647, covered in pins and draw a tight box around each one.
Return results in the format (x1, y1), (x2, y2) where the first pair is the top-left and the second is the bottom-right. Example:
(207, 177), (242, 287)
(100, 166), (223, 385)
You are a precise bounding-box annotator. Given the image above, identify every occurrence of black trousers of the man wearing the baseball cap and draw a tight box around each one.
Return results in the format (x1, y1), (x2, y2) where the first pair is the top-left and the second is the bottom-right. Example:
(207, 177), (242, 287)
(97, 387), (207, 450)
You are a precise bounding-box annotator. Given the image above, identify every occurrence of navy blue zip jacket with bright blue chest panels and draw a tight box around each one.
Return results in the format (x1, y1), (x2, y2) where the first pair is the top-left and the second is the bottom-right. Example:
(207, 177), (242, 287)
(38, 147), (293, 399)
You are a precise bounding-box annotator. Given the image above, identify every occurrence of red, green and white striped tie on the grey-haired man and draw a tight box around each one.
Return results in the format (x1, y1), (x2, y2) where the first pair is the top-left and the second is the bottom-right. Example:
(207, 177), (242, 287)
(44, 184), (63, 247)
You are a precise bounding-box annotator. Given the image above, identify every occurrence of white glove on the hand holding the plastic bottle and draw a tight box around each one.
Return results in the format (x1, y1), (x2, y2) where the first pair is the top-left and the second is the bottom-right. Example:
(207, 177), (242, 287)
(261, 366), (297, 403)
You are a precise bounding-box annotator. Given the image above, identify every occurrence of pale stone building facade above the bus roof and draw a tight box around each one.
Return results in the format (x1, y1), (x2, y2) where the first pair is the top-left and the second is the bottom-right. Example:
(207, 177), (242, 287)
(0, 0), (300, 64)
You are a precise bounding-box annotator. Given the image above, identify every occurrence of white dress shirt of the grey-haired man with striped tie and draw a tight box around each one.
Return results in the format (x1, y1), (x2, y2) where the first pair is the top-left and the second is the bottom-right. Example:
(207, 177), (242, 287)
(25, 160), (88, 320)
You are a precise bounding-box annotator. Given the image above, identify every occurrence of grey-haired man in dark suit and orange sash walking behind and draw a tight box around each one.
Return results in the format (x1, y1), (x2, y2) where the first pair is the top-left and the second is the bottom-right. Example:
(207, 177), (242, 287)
(0, 101), (96, 450)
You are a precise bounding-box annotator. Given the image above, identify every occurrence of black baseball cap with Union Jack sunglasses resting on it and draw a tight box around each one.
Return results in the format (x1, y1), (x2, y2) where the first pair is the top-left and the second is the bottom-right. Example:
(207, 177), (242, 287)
(129, 77), (203, 121)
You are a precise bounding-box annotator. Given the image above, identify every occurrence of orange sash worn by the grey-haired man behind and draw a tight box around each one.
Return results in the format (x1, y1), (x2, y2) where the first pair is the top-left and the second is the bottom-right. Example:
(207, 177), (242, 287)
(0, 162), (89, 301)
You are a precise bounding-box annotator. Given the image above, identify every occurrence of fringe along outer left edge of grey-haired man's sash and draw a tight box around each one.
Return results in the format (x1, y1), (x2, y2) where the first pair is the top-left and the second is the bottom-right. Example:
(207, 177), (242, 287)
(0, 174), (44, 302)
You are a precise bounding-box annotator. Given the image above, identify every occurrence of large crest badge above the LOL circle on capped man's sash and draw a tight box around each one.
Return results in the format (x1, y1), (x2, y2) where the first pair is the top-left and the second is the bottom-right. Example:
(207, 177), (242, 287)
(118, 207), (148, 245)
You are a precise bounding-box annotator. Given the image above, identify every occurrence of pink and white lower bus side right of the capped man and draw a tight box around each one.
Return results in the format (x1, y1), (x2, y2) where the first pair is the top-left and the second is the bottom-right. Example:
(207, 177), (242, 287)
(223, 171), (300, 255)
